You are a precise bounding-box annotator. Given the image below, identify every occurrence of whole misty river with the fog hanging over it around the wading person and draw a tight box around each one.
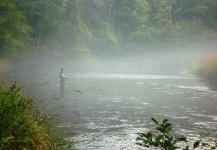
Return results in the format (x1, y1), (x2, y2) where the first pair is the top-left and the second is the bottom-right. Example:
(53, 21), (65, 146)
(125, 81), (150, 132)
(7, 50), (217, 150)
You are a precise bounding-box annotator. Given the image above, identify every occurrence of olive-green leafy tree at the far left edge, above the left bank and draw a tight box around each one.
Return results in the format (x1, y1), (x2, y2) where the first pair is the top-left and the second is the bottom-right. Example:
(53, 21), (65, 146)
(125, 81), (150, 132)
(0, 0), (30, 56)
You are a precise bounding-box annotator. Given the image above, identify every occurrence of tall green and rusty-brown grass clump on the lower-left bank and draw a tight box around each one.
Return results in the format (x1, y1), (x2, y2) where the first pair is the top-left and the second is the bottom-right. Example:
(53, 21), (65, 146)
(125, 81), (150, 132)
(0, 84), (72, 150)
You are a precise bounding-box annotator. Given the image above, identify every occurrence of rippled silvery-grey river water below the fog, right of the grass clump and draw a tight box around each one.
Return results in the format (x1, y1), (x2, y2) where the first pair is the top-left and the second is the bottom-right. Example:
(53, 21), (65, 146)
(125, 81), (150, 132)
(50, 73), (217, 150)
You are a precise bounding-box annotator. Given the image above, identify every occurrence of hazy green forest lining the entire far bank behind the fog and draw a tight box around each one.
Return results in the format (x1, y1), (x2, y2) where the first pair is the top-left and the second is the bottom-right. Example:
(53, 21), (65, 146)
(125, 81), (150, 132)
(0, 0), (217, 58)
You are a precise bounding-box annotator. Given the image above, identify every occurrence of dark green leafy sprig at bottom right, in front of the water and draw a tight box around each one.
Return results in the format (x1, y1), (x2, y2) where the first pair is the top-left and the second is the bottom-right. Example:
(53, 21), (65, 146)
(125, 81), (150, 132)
(136, 118), (216, 150)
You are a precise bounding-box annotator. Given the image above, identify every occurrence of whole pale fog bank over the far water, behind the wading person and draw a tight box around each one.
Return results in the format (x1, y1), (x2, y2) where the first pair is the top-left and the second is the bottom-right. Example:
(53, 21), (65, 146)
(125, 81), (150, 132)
(8, 43), (216, 108)
